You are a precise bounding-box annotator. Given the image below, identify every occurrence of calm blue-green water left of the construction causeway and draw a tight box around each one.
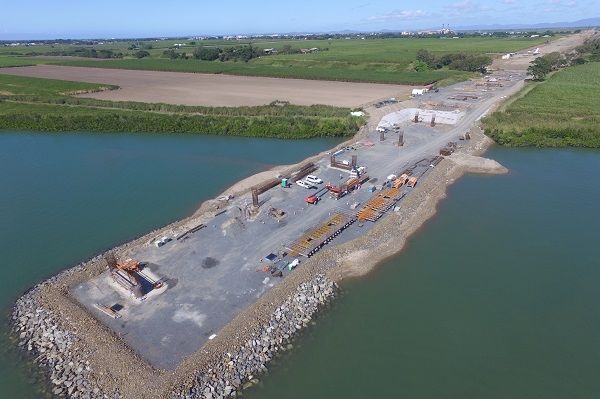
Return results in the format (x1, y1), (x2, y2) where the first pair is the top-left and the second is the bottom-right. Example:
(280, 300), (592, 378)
(0, 132), (337, 399)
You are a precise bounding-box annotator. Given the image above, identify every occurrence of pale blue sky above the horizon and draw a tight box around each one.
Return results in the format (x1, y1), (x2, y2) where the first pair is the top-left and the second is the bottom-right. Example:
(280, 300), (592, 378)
(0, 0), (600, 40)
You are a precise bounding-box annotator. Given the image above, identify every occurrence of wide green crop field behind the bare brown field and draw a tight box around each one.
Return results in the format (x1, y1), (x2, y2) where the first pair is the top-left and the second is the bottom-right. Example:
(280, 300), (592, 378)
(0, 37), (547, 85)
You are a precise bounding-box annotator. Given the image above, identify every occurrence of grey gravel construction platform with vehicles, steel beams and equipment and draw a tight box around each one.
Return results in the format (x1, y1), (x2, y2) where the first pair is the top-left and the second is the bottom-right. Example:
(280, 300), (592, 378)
(70, 72), (524, 369)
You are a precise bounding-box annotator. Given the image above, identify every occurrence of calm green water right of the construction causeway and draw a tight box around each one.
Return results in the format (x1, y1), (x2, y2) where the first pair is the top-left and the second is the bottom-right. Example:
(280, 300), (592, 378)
(247, 148), (600, 399)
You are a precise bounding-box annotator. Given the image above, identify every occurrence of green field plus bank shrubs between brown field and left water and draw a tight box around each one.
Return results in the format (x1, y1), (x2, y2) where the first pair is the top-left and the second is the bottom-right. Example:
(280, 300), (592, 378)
(0, 74), (365, 139)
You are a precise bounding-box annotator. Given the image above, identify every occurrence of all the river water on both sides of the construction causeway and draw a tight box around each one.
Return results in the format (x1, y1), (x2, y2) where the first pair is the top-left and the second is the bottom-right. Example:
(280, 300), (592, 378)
(0, 133), (600, 399)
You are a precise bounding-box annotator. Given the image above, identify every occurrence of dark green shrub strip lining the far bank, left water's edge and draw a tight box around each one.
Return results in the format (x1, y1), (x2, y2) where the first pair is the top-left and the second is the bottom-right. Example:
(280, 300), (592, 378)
(0, 101), (362, 139)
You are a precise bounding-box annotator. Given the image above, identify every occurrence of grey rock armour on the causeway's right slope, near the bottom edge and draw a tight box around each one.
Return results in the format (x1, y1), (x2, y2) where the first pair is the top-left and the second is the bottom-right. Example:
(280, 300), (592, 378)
(173, 274), (337, 399)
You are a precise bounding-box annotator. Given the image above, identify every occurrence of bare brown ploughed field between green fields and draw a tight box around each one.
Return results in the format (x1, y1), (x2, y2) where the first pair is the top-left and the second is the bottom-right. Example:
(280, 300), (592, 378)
(0, 65), (411, 107)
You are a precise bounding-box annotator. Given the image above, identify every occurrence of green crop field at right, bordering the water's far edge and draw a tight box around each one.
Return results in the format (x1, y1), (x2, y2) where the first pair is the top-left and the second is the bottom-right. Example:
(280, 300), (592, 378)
(483, 62), (600, 148)
